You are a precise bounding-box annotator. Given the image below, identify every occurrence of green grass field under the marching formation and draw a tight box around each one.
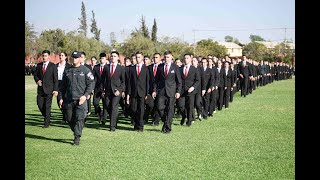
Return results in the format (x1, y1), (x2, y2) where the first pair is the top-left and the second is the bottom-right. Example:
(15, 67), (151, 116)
(25, 76), (295, 180)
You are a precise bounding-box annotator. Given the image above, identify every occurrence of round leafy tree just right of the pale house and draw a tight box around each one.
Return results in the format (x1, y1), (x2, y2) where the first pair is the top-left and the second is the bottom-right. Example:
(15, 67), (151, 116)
(242, 42), (268, 61)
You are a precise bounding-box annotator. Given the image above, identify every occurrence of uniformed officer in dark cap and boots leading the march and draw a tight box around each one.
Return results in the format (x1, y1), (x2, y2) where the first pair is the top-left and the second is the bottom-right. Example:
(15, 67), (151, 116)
(59, 51), (94, 145)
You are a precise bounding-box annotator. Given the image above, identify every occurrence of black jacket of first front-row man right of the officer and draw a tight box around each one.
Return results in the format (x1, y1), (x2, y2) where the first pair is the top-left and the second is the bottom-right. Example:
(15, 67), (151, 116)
(100, 64), (125, 96)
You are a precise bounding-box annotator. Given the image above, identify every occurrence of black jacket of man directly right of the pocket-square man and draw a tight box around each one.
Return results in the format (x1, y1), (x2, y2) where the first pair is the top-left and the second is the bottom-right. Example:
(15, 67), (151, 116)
(180, 65), (200, 94)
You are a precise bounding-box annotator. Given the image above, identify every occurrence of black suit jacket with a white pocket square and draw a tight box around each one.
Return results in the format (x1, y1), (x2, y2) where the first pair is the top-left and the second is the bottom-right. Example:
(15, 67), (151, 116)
(153, 63), (181, 97)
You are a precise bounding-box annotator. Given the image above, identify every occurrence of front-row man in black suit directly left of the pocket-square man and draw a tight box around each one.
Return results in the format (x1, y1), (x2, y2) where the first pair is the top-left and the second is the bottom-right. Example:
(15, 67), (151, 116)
(127, 52), (149, 132)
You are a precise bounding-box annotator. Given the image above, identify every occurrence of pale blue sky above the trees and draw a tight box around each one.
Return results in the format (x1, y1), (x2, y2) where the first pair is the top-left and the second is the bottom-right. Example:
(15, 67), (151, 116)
(25, 0), (295, 44)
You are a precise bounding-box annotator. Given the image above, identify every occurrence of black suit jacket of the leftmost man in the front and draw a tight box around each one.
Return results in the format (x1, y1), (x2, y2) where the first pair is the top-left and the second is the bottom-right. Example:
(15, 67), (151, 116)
(34, 62), (59, 94)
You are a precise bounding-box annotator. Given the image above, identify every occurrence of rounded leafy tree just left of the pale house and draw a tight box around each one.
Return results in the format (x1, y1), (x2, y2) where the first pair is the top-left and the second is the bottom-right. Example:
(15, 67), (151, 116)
(196, 39), (227, 57)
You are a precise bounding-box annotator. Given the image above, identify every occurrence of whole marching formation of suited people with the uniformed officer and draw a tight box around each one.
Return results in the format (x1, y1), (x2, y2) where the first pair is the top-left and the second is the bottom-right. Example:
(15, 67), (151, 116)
(33, 50), (294, 145)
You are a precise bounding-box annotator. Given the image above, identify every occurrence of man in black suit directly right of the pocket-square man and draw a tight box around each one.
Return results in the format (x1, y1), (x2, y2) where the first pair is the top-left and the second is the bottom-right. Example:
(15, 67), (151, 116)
(178, 54), (200, 127)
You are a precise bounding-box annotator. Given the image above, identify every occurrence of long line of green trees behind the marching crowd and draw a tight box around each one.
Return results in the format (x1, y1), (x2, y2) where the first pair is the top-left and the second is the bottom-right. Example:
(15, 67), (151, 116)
(25, 2), (294, 64)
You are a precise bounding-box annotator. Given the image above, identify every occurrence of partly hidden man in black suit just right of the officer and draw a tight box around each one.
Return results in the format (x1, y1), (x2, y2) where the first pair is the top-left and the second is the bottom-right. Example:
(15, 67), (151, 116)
(93, 53), (107, 122)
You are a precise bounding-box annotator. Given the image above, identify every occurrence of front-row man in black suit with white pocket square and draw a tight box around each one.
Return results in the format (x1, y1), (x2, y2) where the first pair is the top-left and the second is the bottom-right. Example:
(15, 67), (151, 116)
(152, 51), (181, 133)
